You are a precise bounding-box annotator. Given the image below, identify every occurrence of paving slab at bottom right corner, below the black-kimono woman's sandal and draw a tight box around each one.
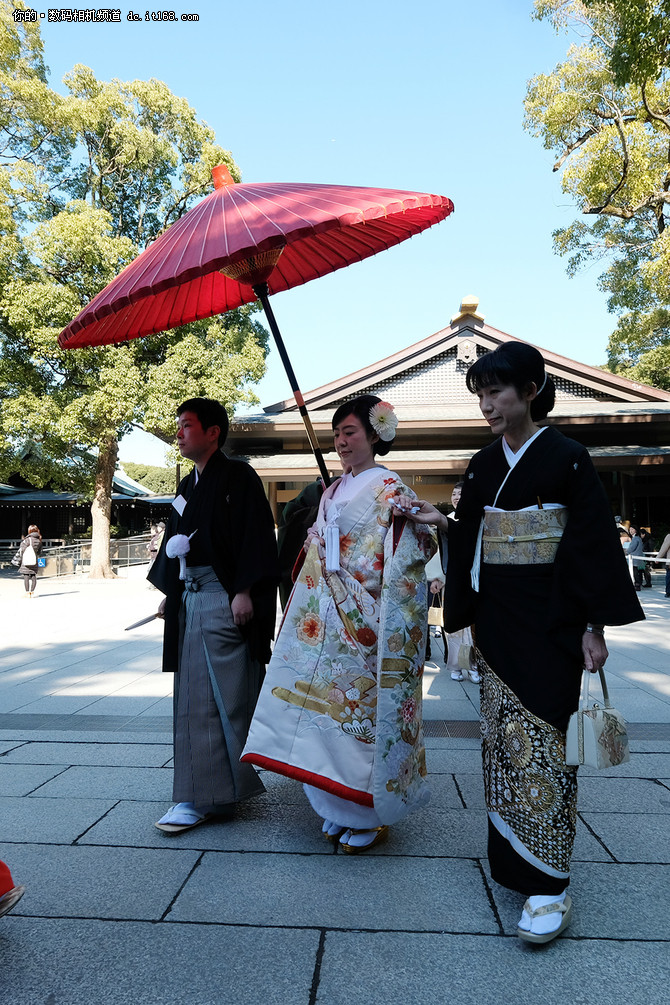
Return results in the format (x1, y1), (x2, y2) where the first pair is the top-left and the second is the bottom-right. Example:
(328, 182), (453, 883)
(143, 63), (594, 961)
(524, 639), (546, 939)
(316, 932), (670, 1005)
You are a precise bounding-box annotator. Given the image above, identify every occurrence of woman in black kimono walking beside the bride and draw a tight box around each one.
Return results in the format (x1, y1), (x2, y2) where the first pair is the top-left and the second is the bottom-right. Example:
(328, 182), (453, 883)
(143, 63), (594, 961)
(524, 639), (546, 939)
(397, 342), (644, 943)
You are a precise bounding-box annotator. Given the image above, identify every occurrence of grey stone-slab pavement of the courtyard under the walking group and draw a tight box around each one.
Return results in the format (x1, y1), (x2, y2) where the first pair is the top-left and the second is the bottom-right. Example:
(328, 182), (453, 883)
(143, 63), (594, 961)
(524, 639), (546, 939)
(0, 571), (670, 1005)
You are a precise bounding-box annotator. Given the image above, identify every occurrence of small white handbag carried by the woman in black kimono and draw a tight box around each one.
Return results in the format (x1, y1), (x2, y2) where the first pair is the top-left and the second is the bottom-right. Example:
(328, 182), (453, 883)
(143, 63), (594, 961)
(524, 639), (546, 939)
(566, 668), (631, 768)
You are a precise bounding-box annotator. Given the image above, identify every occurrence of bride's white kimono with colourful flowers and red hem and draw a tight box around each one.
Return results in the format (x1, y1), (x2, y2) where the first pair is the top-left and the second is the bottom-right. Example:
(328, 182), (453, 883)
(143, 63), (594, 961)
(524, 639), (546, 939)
(242, 467), (435, 824)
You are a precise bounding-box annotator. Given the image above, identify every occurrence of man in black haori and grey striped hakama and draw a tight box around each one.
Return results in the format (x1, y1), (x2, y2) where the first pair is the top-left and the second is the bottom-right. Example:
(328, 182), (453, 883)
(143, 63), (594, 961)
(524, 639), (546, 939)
(148, 398), (279, 834)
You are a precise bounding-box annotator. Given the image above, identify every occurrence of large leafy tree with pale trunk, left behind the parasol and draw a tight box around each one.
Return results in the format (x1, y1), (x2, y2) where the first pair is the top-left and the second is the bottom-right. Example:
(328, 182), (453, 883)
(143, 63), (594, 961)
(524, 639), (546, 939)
(0, 0), (267, 576)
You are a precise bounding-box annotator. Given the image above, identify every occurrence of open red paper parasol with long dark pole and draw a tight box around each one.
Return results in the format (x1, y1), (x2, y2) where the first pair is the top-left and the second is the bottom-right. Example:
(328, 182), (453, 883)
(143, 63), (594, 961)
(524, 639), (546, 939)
(58, 166), (454, 484)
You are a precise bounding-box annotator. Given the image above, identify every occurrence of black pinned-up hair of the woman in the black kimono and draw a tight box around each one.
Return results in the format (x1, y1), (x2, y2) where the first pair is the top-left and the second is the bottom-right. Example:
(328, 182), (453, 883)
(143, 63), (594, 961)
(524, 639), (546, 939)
(465, 342), (555, 420)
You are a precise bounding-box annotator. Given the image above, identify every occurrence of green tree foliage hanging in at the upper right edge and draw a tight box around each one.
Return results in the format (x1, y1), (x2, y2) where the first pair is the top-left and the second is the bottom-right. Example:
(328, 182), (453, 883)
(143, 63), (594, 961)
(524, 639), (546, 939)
(525, 0), (670, 388)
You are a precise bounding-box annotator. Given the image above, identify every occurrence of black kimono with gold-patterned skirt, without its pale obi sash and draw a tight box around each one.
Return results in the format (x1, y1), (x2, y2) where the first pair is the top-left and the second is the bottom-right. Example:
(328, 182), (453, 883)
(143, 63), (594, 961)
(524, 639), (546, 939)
(445, 427), (644, 895)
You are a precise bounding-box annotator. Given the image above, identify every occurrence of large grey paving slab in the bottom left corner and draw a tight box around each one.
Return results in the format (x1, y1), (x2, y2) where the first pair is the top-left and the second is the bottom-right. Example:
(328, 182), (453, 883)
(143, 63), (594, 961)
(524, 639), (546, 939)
(0, 920), (319, 1005)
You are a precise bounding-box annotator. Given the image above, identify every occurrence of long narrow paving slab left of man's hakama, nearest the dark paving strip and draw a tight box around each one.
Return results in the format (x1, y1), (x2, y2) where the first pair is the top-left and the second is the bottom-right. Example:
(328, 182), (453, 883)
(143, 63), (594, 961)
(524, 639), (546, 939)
(0, 740), (172, 768)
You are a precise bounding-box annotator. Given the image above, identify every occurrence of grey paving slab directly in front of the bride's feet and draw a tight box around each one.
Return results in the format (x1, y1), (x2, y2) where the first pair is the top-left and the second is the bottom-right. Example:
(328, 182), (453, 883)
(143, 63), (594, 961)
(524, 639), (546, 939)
(167, 852), (498, 934)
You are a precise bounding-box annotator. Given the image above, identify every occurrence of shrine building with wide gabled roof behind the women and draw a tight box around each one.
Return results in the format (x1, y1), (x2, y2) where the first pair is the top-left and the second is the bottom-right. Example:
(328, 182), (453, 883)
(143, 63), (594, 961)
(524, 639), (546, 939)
(226, 297), (670, 529)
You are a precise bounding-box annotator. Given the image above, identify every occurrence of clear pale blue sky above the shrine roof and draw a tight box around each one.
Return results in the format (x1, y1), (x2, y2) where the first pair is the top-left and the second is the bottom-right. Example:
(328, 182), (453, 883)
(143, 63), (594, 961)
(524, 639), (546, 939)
(34, 0), (615, 464)
